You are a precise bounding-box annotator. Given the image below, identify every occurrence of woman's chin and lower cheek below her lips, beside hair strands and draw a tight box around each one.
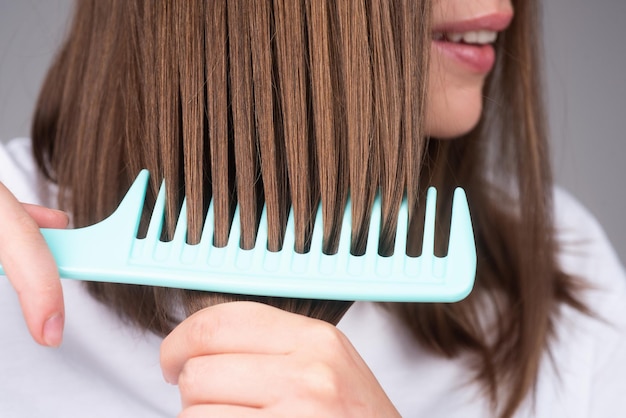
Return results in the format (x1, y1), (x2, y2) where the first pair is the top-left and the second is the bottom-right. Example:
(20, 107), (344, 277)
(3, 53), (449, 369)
(425, 49), (484, 139)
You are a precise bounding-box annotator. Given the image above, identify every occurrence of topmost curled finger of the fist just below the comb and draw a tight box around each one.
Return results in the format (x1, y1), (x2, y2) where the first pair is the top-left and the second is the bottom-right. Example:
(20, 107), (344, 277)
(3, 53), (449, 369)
(161, 302), (320, 383)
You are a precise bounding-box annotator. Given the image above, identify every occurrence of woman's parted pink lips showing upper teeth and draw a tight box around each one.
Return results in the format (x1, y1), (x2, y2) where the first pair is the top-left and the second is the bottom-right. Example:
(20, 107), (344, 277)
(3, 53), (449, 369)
(432, 13), (513, 74)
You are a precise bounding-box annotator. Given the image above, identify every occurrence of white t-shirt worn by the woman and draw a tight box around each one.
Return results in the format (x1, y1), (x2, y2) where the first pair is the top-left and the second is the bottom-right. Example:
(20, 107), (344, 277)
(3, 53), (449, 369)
(0, 139), (626, 418)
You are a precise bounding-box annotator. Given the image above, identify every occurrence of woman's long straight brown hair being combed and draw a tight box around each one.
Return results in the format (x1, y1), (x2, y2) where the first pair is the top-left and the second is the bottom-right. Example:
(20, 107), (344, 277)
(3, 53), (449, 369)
(32, 0), (582, 416)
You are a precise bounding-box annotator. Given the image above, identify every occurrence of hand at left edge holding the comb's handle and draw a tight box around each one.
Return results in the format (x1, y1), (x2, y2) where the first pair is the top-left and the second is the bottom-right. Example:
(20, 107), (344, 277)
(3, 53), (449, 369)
(0, 183), (68, 347)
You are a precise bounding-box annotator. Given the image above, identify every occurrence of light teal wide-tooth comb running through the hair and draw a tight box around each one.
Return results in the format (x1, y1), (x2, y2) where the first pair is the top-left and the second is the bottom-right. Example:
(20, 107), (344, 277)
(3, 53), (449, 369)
(0, 170), (476, 302)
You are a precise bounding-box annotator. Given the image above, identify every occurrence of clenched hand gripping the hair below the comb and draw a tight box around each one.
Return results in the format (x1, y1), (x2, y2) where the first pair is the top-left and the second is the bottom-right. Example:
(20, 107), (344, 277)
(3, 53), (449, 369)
(161, 302), (399, 418)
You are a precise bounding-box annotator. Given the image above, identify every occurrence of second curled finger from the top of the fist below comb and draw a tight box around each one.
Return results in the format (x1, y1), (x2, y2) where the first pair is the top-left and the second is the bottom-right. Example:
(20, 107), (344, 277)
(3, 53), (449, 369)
(178, 354), (358, 416)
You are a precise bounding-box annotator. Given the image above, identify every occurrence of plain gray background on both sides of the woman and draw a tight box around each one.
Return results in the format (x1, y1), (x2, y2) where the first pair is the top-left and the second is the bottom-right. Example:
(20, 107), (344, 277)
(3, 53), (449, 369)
(0, 0), (626, 262)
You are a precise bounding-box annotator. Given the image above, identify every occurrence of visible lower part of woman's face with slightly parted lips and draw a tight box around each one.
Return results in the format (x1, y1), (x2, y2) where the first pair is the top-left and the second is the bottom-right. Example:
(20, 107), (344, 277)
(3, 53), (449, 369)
(426, 0), (513, 138)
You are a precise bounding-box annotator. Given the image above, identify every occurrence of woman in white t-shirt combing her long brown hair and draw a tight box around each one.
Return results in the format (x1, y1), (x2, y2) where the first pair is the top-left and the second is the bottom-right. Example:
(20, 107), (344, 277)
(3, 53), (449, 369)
(0, 0), (626, 417)
